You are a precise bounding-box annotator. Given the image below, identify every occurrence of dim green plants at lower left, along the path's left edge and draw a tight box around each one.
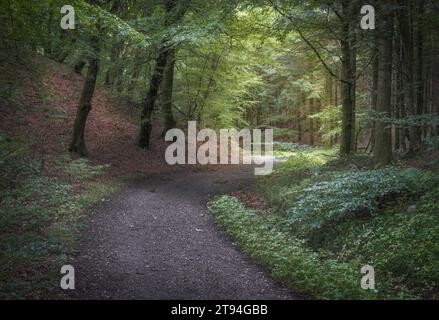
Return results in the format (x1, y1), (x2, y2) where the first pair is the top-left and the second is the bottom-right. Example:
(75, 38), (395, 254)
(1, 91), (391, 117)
(0, 136), (118, 299)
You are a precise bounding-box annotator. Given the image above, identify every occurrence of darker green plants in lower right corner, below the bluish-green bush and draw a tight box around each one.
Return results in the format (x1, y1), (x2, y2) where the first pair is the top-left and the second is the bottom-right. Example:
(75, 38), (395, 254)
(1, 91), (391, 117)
(327, 188), (439, 299)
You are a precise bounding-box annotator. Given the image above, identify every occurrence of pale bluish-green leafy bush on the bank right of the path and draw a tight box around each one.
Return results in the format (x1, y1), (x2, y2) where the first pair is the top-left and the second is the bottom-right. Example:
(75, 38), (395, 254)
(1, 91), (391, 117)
(287, 168), (437, 235)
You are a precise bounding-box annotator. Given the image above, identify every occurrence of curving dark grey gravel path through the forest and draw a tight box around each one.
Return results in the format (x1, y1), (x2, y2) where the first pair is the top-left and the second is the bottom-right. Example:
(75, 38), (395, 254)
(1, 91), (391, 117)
(72, 166), (295, 300)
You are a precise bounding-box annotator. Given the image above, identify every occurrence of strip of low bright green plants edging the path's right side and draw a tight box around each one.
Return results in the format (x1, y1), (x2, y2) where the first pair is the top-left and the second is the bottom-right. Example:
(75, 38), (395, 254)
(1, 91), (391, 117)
(209, 197), (379, 299)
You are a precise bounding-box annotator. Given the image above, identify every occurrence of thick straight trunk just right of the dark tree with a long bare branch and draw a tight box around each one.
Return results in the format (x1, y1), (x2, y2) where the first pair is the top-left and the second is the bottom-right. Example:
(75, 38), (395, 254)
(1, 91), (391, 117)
(375, 5), (393, 165)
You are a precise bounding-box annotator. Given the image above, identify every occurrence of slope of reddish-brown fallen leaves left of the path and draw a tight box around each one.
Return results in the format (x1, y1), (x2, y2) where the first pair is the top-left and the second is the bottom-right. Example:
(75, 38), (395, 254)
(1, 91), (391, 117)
(0, 52), (173, 176)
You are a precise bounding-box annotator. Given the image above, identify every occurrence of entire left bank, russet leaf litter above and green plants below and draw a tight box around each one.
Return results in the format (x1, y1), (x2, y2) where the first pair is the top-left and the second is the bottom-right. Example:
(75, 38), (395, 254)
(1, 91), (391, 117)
(0, 51), (178, 299)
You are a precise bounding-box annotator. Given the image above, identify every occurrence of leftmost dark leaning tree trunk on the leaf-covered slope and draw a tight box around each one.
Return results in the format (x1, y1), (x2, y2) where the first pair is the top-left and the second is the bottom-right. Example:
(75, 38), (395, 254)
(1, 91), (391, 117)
(69, 57), (99, 157)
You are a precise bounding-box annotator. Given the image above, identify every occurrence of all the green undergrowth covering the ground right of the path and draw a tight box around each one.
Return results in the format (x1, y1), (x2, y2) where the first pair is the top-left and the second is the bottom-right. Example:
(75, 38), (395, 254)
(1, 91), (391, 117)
(209, 148), (439, 299)
